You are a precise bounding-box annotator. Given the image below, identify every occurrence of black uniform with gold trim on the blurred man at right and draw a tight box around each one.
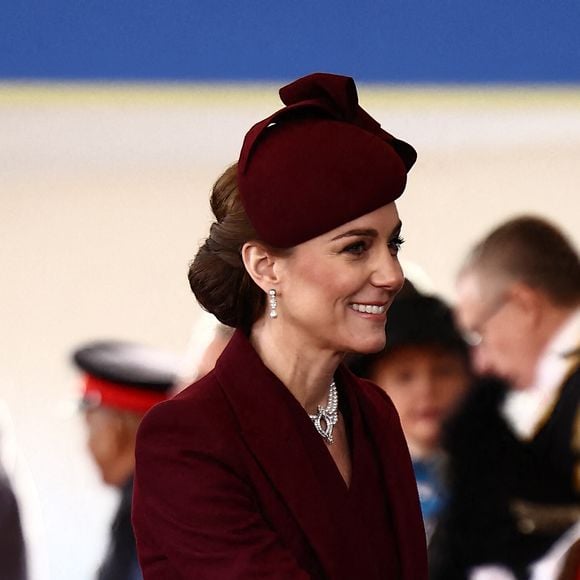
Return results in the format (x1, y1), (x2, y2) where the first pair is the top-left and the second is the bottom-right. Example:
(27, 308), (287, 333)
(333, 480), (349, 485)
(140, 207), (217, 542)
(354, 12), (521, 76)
(430, 365), (580, 580)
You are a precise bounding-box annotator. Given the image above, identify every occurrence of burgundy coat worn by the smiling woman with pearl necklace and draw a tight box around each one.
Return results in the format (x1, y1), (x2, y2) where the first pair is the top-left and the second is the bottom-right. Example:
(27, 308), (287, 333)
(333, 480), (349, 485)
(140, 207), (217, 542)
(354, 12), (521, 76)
(133, 331), (427, 580)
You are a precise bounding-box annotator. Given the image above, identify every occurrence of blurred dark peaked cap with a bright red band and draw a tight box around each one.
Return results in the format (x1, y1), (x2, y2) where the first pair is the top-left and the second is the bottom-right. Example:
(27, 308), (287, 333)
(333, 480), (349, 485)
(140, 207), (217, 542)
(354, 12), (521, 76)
(72, 340), (179, 413)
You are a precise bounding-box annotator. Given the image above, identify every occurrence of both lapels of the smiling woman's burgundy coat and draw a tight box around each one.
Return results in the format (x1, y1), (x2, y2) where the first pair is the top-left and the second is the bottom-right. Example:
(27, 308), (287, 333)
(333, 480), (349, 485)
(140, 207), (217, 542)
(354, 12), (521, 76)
(215, 330), (427, 580)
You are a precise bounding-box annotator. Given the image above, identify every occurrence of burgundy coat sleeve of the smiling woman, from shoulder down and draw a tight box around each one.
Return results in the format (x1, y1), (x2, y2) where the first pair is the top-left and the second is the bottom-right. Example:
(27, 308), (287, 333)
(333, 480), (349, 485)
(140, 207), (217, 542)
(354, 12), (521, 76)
(133, 400), (309, 580)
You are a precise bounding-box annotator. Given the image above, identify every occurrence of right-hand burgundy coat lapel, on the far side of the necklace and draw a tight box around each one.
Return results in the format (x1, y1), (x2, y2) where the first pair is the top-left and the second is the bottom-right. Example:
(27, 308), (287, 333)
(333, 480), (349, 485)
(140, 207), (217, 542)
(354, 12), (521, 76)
(338, 366), (428, 580)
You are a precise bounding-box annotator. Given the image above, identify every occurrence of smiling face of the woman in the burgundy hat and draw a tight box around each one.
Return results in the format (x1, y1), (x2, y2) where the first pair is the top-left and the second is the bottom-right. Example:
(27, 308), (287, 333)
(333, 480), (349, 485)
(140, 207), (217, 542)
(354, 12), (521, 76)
(274, 203), (403, 353)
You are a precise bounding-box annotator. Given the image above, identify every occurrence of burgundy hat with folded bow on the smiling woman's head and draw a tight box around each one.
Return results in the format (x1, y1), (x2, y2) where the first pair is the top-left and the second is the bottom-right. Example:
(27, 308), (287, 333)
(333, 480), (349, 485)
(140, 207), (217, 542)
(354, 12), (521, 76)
(238, 73), (417, 248)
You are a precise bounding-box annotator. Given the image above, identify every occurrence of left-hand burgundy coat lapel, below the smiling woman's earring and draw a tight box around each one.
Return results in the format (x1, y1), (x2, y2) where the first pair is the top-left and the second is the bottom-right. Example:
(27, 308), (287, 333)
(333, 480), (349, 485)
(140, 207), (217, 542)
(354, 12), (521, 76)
(215, 330), (340, 578)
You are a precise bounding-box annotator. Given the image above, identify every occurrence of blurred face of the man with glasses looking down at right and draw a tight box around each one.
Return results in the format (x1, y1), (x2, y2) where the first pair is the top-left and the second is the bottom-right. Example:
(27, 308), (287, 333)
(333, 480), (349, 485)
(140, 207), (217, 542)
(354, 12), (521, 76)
(456, 272), (538, 389)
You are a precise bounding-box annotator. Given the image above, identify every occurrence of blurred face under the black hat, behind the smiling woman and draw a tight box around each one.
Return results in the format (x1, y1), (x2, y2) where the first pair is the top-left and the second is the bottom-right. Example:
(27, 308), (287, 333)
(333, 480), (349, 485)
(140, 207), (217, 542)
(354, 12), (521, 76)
(369, 346), (469, 456)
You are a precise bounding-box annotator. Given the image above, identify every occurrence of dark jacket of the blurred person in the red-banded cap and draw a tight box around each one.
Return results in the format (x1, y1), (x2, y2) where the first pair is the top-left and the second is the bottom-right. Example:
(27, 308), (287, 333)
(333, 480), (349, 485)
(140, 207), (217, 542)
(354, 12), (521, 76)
(97, 477), (143, 580)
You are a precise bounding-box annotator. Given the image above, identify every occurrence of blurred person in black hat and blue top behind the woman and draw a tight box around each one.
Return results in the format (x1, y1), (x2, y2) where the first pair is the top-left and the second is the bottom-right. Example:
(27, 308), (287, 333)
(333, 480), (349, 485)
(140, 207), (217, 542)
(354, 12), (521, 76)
(351, 292), (471, 539)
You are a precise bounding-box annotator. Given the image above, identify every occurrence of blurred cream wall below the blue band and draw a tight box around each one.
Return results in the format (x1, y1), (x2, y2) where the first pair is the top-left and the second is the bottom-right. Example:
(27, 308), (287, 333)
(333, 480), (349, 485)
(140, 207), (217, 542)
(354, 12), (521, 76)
(0, 85), (580, 580)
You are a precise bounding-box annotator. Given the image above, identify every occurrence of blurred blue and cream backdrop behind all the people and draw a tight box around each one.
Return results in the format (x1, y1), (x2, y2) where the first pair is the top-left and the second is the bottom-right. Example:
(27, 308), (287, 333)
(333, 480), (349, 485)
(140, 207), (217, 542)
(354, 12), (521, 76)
(0, 0), (580, 580)
